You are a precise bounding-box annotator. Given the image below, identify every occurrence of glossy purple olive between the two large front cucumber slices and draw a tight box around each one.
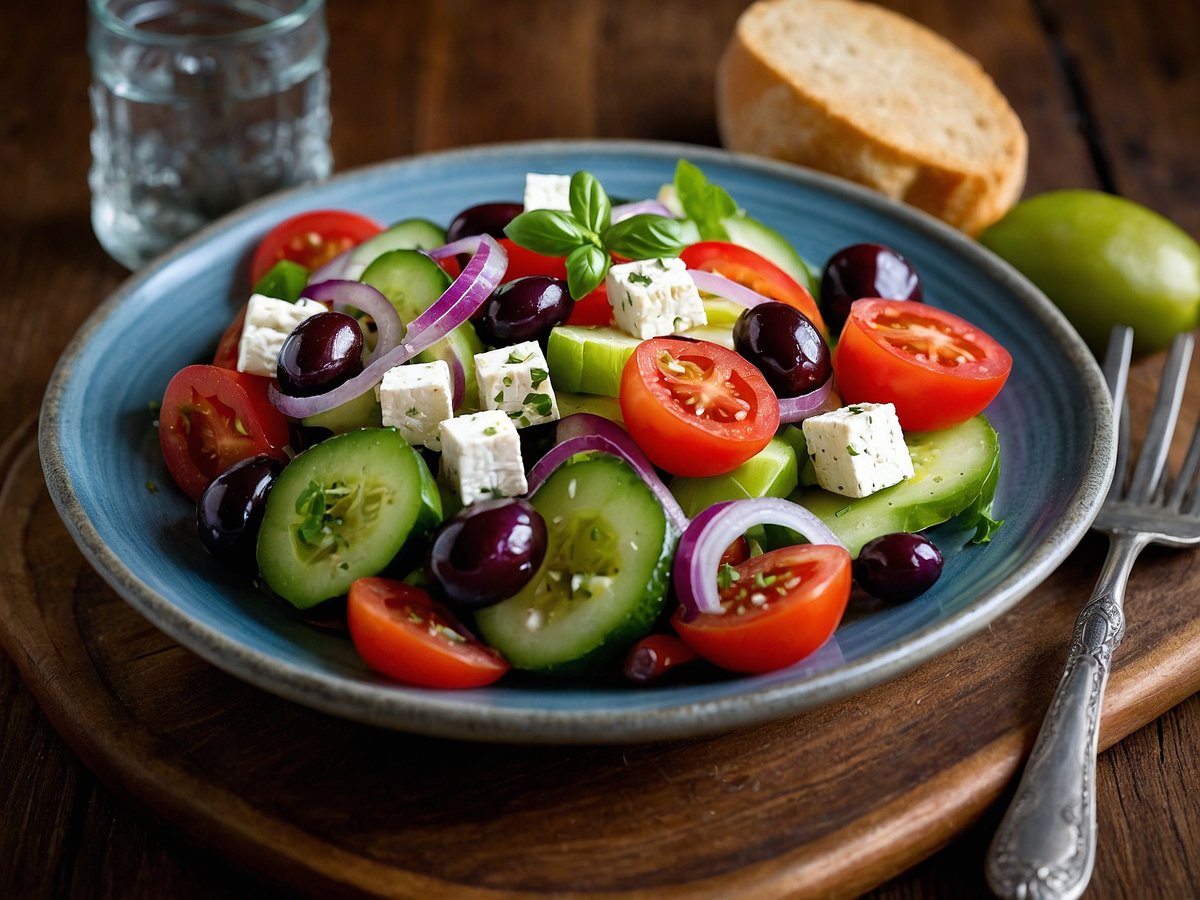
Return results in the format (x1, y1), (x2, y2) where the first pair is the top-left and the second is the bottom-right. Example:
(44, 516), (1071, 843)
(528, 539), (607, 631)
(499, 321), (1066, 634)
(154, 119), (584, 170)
(426, 498), (546, 610)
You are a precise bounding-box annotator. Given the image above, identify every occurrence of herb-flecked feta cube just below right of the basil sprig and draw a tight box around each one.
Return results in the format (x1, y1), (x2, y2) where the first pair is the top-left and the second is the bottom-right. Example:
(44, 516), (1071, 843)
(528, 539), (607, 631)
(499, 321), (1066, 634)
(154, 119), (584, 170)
(605, 258), (708, 341)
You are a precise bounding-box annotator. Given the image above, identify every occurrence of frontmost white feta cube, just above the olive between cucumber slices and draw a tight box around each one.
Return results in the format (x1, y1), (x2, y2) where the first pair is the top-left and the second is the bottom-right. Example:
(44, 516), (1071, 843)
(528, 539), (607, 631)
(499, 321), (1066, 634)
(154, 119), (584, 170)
(440, 409), (529, 506)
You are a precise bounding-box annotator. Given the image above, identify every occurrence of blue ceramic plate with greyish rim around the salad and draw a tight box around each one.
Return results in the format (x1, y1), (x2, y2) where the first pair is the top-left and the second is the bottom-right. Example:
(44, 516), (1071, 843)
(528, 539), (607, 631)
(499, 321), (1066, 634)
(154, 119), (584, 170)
(41, 142), (1112, 743)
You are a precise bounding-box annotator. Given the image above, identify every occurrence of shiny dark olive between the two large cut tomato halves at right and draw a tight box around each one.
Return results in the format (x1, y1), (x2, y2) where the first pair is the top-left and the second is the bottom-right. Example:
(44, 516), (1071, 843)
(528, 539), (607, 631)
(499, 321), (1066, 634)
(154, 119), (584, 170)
(733, 300), (833, 397)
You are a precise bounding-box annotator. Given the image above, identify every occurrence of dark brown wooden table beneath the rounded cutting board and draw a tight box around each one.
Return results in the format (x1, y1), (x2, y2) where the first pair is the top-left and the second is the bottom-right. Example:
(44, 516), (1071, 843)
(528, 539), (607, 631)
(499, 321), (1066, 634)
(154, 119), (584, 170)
(0, 0), (1200, 900)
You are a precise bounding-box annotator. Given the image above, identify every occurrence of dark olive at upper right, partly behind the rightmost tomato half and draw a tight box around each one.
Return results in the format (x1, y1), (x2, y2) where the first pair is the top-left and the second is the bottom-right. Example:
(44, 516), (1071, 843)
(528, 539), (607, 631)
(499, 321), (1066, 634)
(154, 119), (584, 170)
(821, 244), (920, 335)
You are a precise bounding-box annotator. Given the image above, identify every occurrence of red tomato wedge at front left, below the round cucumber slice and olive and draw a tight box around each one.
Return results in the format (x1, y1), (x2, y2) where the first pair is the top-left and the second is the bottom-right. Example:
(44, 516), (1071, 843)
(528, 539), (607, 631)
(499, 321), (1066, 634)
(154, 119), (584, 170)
(346, 578), (509, 689)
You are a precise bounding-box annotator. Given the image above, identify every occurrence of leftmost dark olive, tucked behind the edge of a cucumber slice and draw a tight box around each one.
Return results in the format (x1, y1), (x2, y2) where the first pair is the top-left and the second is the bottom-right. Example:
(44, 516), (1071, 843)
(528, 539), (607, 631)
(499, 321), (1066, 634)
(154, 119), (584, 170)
(196, 456), (283, 569)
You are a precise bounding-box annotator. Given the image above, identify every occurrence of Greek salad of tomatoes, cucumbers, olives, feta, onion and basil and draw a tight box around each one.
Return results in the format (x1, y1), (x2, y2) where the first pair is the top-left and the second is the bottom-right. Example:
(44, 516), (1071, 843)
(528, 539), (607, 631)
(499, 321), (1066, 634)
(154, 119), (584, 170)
(158, 160), (1012, 689)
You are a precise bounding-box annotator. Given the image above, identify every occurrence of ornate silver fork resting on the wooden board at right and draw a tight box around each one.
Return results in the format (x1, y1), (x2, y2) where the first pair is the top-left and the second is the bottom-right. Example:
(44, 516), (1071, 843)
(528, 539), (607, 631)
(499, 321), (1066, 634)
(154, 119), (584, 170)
(986, 328), (1200, 900)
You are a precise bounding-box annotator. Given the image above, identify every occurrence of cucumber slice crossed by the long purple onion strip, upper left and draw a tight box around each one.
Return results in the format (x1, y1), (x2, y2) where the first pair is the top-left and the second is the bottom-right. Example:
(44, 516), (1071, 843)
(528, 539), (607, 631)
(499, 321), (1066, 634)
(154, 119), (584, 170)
(361, 250), (484, 412)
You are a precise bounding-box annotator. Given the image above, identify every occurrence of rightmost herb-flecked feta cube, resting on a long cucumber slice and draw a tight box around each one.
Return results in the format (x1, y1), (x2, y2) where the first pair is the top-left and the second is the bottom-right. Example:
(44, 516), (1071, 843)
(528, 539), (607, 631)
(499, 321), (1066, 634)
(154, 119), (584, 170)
(802, 403), (913, 497)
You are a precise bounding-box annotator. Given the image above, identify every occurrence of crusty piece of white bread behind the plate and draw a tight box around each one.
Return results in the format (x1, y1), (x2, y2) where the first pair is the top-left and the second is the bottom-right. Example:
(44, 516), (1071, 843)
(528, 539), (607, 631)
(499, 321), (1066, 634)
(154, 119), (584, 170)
(716, 0), (1028, 234)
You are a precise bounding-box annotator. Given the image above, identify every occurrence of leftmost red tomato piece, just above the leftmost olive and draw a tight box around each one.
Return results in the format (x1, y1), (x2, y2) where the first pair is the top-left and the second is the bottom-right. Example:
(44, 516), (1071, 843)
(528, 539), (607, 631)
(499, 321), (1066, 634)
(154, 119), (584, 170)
(158, 365), (288, 500)
